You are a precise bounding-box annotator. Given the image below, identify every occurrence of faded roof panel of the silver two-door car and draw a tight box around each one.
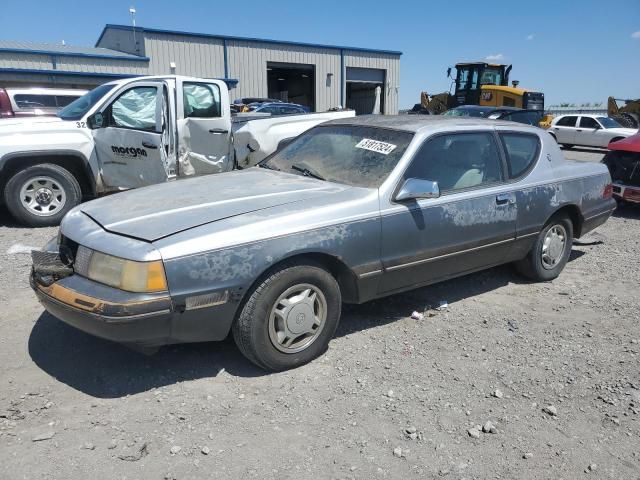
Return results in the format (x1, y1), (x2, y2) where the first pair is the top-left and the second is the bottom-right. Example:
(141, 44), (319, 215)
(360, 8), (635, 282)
(322, 115), (524, 133)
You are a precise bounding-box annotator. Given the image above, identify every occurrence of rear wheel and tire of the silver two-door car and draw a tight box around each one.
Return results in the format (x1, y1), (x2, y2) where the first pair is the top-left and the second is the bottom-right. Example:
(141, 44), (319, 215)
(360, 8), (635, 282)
(515, 213), (573, 282)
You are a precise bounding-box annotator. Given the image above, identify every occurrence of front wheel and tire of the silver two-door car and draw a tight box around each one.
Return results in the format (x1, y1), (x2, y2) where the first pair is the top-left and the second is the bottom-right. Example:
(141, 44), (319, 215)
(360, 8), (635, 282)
(232, 263), (342, 371)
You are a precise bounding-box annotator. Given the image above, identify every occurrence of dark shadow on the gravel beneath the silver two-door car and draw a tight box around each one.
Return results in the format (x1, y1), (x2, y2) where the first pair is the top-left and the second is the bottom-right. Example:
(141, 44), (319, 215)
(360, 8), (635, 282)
(29, 250), (584, 398)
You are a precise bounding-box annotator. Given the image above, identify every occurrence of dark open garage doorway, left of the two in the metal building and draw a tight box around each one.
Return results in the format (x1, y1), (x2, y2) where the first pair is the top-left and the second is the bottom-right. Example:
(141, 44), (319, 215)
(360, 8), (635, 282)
(267, 62), (316, 112)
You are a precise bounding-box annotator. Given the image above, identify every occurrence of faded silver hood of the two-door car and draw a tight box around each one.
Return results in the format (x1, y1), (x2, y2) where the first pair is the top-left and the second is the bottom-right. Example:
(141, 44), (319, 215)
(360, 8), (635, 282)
(77, 167), (351, 242)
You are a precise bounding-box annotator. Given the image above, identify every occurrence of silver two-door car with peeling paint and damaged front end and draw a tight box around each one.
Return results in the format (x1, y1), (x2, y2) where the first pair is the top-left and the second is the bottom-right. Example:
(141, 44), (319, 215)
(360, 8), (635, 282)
(31, 116), (615, 370)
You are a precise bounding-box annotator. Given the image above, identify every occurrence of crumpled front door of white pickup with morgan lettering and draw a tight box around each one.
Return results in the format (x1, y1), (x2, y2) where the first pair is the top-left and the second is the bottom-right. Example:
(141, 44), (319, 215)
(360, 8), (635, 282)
(88, 81), (175, 190)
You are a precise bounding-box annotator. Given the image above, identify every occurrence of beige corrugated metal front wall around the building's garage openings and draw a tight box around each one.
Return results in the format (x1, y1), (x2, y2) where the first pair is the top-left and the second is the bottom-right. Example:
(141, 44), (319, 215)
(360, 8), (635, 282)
(133, 30), (400, 114)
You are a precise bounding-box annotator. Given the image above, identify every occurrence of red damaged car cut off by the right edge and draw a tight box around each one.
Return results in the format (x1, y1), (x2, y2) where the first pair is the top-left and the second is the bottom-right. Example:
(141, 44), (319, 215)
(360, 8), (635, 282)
(602, 133), (640, 204)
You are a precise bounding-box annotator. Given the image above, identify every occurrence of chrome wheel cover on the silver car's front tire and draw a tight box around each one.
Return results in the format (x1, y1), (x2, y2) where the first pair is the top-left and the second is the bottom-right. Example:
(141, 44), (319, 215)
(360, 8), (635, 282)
(269, 283), (327, 353)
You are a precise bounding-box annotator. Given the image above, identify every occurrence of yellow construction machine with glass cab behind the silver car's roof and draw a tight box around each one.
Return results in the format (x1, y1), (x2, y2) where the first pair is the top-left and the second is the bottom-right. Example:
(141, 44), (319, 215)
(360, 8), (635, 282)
(413, 62), (544, 115)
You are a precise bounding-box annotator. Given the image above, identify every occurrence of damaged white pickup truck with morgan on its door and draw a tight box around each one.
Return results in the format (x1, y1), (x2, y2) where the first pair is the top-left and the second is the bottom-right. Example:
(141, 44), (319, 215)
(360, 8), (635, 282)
(0, 75), (355, 226)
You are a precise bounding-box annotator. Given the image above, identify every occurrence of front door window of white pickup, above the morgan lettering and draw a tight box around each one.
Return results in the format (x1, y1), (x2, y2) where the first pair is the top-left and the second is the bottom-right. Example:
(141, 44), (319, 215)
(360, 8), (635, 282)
(107, 87), (160, 131)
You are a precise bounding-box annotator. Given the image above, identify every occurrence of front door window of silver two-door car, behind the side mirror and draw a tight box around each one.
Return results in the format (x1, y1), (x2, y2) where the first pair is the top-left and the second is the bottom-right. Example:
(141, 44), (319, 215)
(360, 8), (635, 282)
(404, 132), (502, 192)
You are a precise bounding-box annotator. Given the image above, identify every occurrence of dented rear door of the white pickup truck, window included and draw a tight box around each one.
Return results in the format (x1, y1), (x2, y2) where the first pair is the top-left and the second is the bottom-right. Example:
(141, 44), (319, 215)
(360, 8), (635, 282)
(176, 79), (233, 177)
